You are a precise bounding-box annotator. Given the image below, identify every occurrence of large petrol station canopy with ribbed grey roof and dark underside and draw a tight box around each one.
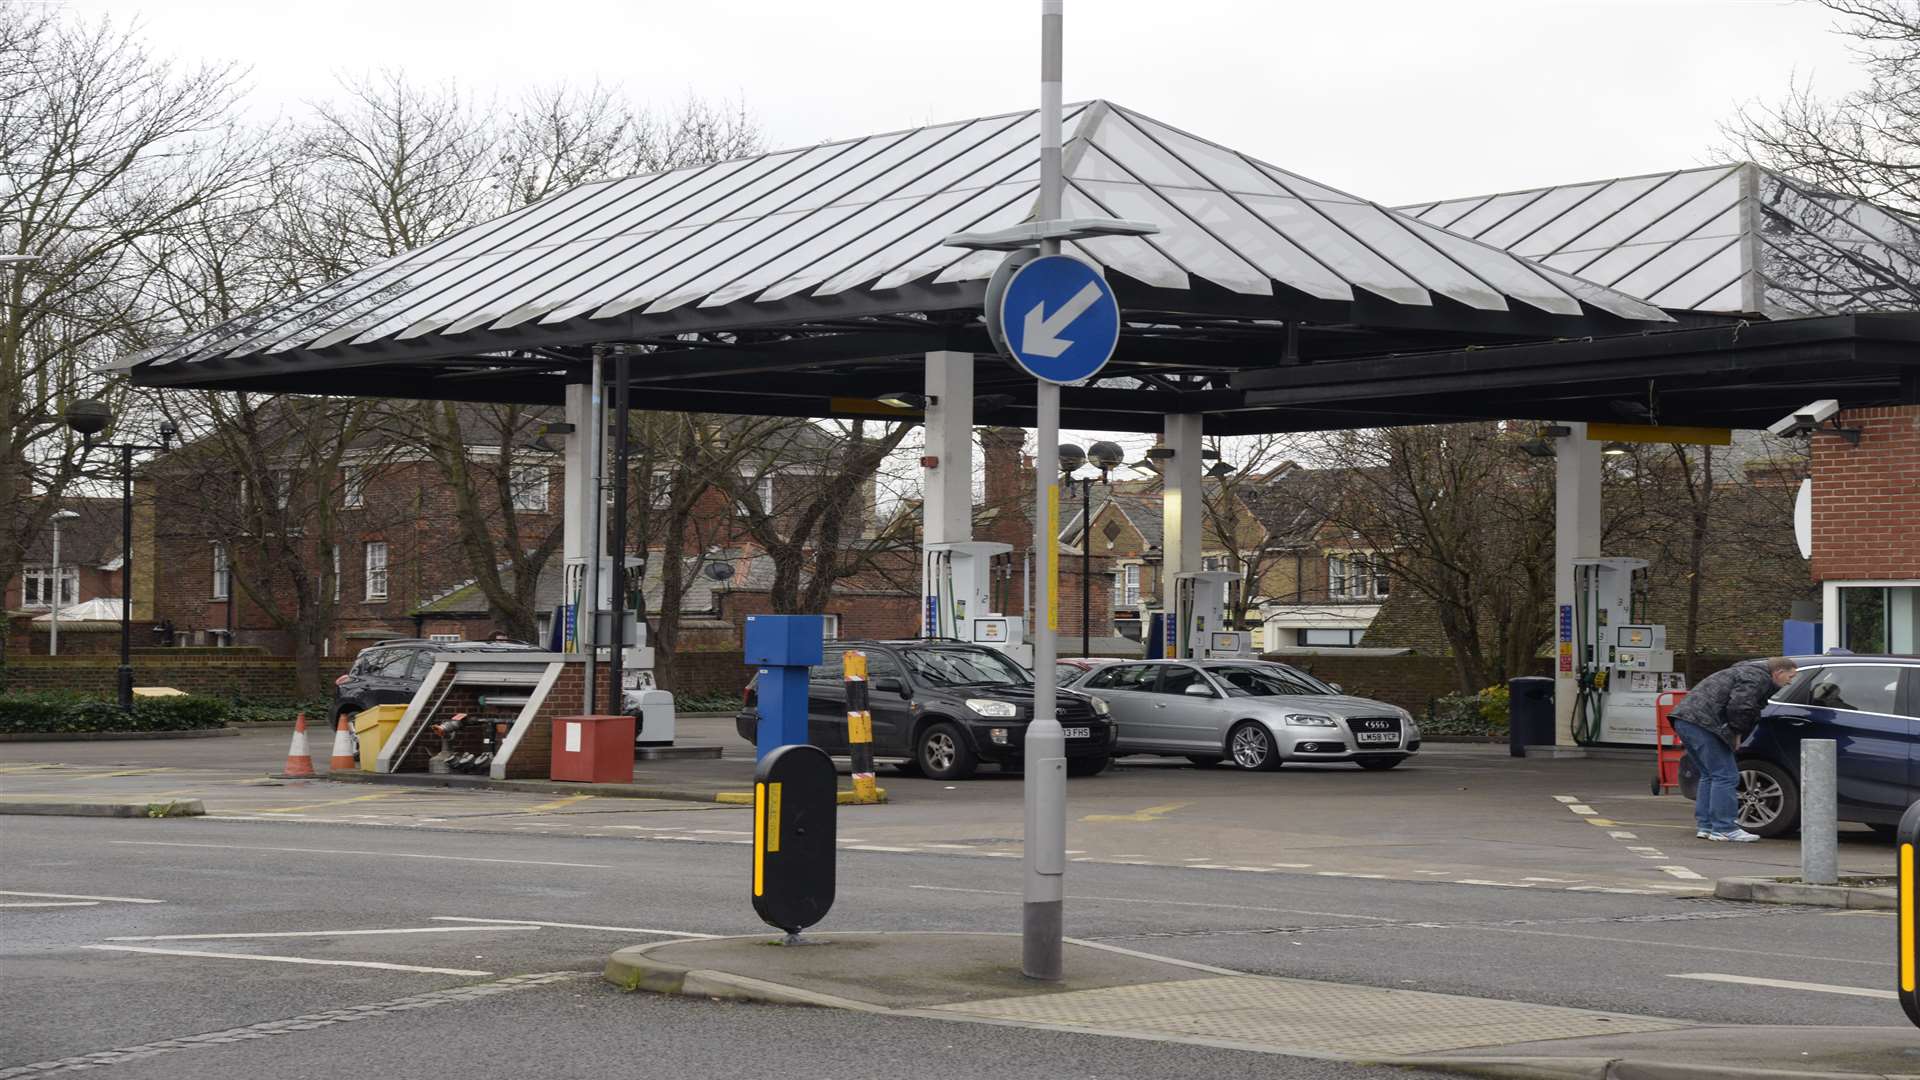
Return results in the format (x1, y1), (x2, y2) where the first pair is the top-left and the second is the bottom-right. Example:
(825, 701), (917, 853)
(129, 100), (1920, 434)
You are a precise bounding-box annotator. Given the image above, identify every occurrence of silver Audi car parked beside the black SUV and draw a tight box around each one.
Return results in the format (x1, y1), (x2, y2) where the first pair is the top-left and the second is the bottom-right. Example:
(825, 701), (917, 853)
(1073, 659), (1421, 771)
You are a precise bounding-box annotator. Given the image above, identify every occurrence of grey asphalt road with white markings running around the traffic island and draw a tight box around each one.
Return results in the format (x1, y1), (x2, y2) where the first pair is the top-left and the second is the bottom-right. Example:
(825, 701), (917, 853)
(0, 807), (1899, 1078)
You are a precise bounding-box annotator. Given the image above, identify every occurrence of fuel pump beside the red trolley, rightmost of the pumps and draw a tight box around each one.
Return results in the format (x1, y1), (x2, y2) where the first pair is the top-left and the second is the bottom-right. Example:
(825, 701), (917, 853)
(1572, 559), (1686, 746)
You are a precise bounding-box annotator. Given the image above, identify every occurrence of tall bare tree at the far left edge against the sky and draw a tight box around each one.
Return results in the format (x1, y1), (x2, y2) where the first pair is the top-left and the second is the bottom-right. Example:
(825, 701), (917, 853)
(0, 0), (263, 680)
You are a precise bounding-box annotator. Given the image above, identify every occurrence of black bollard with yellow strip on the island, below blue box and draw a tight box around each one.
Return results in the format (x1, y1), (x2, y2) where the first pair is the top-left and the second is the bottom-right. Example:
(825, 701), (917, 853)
(753, 746), (839, 944)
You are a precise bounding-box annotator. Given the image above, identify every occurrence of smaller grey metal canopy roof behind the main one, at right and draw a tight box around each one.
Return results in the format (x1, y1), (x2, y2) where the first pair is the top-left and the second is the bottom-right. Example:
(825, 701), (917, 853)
(1402, 163), (1920, 319)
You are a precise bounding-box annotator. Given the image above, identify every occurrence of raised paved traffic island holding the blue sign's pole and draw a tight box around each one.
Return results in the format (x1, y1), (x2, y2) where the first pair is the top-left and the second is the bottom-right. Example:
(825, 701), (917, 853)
(603, 932), (1920, 1080)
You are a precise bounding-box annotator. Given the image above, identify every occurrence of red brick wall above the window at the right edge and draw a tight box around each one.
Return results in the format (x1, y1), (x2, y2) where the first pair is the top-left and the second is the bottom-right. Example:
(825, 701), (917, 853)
(1812, 405), (1920, 580)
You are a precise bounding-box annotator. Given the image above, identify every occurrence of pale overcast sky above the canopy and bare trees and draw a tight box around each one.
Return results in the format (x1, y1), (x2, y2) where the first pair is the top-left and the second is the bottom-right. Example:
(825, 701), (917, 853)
(93, 0), (1857, 204)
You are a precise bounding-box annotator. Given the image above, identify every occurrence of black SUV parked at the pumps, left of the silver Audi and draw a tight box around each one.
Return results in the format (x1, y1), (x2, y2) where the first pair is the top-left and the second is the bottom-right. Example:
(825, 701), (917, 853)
(733, 640), (1117, 780)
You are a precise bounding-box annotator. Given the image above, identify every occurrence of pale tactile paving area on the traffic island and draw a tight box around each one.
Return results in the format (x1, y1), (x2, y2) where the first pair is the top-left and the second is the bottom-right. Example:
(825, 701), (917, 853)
(935, 976), (1692, 1055)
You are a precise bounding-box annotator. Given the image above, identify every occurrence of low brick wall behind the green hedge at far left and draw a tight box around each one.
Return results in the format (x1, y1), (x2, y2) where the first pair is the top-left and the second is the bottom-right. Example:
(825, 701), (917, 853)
(0, 645), (346, 700)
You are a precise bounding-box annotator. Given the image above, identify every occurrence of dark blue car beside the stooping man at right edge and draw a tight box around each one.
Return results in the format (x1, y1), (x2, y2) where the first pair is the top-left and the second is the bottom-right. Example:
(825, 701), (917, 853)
(1680, 655), (1920, 836)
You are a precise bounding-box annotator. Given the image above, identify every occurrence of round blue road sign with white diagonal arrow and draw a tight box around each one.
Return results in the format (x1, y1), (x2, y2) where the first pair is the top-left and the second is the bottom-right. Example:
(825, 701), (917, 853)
(995, 256), (1119, 382)
